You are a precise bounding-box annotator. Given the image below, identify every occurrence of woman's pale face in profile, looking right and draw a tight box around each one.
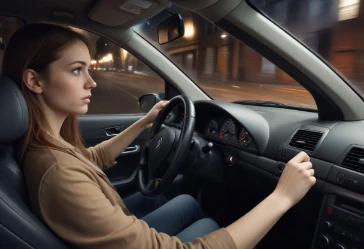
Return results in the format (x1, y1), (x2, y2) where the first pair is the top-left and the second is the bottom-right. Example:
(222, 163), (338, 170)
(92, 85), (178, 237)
(38, 40), (96, 115)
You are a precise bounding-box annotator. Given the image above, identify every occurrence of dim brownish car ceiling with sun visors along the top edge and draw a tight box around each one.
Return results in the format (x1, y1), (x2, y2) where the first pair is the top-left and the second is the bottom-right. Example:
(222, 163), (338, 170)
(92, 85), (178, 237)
(0, 0), (242, 44)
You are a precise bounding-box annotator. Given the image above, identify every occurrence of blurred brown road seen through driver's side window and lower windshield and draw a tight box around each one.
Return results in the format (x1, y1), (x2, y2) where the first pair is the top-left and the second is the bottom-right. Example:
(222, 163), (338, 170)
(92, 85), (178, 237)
(88, 71), (316, 114)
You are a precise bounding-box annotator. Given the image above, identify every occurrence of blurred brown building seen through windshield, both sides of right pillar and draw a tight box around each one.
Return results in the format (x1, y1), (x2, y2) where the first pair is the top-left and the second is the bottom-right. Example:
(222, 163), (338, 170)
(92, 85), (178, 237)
(157, 0), (364, 87)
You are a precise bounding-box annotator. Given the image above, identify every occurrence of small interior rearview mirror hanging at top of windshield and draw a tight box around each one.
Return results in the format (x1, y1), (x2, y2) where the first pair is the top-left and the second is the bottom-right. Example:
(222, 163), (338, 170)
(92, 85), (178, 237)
(158, 14), (185, 45)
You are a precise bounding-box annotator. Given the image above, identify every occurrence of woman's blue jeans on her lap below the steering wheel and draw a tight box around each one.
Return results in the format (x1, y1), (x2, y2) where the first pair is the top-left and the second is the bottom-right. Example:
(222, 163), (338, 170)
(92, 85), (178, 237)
(124, 193), (220, 242)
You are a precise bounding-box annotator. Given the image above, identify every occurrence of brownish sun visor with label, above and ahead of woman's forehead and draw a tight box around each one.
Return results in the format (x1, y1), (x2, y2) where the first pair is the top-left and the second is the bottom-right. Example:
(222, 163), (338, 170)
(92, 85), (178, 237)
(88, 0), (169, 28)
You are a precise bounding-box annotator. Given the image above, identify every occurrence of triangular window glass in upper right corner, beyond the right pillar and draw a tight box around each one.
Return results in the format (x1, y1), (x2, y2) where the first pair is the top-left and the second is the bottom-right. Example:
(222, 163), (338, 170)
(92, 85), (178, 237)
(250, 0), (364, 97)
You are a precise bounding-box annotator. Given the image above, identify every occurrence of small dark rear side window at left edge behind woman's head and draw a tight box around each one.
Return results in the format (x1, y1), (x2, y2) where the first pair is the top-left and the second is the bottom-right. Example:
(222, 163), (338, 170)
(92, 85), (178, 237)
(0, 16), (23, 74)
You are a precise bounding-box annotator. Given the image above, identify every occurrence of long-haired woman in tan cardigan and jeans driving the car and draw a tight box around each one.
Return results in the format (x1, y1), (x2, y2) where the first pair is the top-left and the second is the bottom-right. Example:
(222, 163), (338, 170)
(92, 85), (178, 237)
(3, 24), (316, 249)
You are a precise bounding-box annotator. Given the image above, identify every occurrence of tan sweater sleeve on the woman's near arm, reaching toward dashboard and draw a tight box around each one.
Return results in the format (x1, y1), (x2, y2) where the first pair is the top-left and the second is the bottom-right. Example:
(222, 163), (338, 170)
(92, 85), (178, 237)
(39, 164), (236, 249)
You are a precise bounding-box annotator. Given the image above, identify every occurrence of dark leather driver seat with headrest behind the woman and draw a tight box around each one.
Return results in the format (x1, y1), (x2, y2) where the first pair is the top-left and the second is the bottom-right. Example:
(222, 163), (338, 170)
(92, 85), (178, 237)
(0, 76), (71, 249)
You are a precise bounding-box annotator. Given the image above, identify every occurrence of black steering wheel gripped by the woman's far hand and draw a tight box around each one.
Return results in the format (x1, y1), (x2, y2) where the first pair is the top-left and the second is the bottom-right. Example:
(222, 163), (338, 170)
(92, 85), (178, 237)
(138, 95), (196, 197)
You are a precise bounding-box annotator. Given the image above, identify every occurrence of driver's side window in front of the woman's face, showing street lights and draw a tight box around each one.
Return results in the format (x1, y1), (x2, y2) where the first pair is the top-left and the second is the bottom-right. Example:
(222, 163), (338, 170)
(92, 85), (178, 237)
(76, 29), (165, 114)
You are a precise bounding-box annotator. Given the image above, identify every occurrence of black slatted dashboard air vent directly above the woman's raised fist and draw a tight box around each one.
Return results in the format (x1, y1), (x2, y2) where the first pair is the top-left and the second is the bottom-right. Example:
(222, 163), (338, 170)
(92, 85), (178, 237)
(289, 130), (323, 151)
